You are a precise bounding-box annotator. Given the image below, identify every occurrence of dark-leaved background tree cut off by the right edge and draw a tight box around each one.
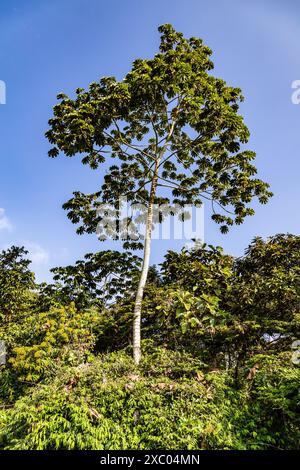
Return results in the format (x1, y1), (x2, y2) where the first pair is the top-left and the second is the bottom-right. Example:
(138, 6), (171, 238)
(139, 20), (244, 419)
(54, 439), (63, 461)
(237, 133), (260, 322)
(230, 234), (300, 357)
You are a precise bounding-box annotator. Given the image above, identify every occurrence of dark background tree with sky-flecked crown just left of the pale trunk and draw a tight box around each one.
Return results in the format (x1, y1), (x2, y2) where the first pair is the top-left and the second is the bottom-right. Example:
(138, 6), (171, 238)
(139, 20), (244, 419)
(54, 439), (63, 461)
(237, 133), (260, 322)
(37, 250), (141, 310)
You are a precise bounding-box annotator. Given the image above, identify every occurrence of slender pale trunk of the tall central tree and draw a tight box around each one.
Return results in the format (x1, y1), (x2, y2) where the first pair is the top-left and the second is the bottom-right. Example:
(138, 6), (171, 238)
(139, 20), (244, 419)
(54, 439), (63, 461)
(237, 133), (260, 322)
(133, 158), (160, 365)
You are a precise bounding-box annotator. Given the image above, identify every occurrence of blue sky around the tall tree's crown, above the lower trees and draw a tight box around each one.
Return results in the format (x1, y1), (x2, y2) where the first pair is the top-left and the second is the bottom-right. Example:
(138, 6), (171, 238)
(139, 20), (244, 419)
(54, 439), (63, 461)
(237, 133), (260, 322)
(0, 0), (300, 281)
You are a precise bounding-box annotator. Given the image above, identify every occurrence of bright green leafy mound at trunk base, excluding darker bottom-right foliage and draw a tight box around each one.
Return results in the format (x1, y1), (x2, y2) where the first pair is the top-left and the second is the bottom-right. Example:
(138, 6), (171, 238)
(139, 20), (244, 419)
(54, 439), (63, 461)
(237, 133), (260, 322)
(0, 350), (238, 449)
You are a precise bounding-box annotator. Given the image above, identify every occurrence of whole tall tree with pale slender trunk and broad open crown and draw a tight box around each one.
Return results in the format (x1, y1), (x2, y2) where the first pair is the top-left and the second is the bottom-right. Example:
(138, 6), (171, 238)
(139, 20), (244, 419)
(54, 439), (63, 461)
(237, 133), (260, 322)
(46, 24), (271, 363)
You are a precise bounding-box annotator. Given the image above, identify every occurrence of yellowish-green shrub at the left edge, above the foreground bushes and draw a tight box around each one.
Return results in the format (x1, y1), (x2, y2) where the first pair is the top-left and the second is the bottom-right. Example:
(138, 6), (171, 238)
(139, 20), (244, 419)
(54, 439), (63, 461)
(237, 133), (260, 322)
(0, 304), (99, 402)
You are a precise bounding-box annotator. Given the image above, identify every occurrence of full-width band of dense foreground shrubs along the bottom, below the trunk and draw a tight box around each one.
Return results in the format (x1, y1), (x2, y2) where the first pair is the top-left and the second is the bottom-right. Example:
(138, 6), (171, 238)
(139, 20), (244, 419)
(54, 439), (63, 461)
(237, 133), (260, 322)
(0, 346), (300, 449)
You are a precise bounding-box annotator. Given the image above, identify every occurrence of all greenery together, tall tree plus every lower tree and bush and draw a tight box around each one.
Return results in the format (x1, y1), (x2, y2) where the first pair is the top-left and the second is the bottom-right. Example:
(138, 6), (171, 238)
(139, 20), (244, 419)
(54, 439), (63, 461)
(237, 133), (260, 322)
(0, 25), (300, 450)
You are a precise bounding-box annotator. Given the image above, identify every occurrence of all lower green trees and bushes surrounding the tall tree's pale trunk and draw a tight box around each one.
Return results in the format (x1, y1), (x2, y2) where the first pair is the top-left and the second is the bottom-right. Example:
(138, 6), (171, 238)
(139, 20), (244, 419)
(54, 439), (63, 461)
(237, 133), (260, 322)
(0, 235), (300, 449)
